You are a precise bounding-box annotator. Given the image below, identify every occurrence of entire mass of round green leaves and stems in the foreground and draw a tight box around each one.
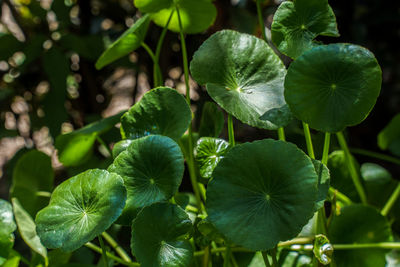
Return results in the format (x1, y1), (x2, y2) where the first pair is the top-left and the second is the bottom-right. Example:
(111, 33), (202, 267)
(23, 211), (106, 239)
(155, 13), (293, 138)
(0, 0), (400, 267)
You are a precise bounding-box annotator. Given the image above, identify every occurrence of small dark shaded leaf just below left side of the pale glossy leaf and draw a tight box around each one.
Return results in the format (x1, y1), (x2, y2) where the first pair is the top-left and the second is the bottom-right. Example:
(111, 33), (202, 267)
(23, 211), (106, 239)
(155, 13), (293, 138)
(199, 102), (225, 137)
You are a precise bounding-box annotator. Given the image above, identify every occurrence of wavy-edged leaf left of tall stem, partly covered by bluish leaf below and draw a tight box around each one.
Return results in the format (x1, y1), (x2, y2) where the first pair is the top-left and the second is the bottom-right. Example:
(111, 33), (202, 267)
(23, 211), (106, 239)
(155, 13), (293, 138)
(121, 87), (192, 141)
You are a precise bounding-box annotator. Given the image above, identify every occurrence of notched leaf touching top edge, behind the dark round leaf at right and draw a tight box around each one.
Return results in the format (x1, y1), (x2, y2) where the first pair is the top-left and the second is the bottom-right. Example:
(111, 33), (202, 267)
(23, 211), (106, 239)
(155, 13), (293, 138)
(271, 0), (339, 58)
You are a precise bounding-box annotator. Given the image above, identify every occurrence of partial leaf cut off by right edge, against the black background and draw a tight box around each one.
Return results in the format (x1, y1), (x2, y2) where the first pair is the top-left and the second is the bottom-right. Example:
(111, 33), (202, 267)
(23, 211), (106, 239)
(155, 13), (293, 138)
(378, 114), (400, 156)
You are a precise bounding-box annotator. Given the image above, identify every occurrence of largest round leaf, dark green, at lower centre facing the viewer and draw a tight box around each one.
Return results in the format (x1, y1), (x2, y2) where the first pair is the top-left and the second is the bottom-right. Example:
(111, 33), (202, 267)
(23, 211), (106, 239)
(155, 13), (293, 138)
(206, 139), (317, 250)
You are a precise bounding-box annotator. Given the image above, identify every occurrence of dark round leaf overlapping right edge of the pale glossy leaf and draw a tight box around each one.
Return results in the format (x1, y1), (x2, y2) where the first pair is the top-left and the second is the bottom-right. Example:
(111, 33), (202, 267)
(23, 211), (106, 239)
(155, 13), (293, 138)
(285, 44), (382, 133)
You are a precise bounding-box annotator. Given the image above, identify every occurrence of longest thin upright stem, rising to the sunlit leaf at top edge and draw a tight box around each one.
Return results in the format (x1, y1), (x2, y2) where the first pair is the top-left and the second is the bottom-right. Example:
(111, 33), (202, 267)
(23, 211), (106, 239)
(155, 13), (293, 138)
(176, 7), (205, 216)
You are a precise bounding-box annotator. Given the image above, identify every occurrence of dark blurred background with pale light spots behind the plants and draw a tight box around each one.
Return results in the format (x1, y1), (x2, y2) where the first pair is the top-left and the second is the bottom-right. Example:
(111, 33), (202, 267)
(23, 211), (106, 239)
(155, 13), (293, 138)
(0, 0), (400, 198)
